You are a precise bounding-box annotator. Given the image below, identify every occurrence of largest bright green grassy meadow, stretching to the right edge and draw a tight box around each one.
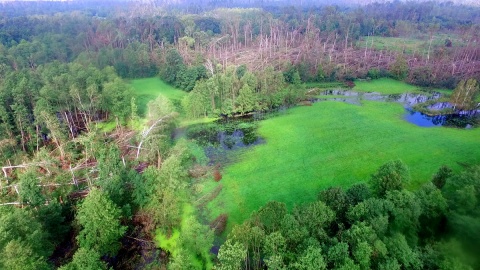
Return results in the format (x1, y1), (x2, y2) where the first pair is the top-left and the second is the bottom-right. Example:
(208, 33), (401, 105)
(208, 98), (480, 226)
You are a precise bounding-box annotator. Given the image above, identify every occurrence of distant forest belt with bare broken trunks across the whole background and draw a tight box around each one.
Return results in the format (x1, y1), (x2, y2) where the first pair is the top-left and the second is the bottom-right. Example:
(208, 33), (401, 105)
(0, 2), (480, 88)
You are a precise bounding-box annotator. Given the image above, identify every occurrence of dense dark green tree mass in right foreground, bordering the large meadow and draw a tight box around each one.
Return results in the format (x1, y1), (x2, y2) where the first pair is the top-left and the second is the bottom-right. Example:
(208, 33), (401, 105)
(216, 161), (480, 270)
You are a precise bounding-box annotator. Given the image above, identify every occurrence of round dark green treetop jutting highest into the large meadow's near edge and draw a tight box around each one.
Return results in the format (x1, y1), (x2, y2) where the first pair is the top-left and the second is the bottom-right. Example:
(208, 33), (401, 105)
(370, 160), (410, 196)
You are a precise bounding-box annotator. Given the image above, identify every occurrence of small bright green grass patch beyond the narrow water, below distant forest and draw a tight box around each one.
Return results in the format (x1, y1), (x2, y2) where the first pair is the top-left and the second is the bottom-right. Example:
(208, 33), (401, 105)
(353, 78), (420, 95)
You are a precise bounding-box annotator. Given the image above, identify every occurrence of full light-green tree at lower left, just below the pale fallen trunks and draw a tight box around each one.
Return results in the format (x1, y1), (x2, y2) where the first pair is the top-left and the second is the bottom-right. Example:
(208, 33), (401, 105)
(76, 188), (126, 256)
